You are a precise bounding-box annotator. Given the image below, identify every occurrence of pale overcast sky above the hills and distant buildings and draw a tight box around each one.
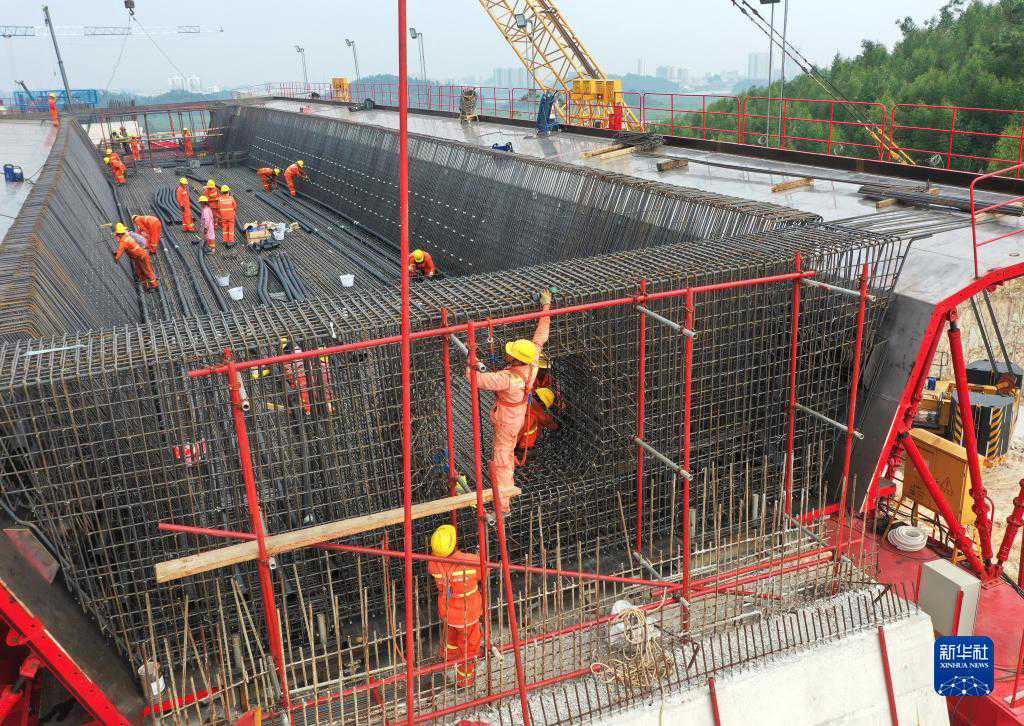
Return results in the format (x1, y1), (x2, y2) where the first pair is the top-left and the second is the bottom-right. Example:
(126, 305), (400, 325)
(0, 0), (945, 92)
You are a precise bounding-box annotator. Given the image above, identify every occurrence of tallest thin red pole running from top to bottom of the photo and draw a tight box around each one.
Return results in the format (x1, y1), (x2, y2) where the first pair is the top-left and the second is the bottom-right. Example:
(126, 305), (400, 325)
(398, 0), (416, 726)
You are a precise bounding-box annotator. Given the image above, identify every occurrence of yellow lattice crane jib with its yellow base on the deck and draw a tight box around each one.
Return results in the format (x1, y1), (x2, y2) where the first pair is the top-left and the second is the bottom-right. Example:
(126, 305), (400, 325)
(480, 0), (643, 131)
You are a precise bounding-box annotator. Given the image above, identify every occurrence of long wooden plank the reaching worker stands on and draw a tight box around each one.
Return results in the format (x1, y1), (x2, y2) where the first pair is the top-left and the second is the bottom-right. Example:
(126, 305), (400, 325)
(155, 485), (520, 583)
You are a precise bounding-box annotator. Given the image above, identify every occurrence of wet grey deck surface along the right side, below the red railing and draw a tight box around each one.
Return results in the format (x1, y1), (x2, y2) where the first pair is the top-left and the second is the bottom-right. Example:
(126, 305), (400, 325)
(261, 99), (1024, 302)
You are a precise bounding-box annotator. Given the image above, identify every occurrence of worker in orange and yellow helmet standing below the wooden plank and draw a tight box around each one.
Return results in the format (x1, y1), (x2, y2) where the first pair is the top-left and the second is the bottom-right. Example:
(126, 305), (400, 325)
(427, 524), (483, 686)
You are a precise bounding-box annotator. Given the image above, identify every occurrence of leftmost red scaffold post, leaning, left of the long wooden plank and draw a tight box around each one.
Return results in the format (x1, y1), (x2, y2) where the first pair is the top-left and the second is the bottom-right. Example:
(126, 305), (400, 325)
(227, 359), (292, 712)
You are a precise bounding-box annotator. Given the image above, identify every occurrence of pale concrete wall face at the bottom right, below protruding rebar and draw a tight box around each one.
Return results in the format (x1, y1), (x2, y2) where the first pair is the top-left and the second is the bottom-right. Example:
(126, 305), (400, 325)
(597, 612), (949, 726)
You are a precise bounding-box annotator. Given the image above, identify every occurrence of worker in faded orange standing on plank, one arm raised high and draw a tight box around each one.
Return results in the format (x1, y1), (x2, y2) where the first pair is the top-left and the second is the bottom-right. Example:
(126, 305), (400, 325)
(466, 290), (551, 512)
